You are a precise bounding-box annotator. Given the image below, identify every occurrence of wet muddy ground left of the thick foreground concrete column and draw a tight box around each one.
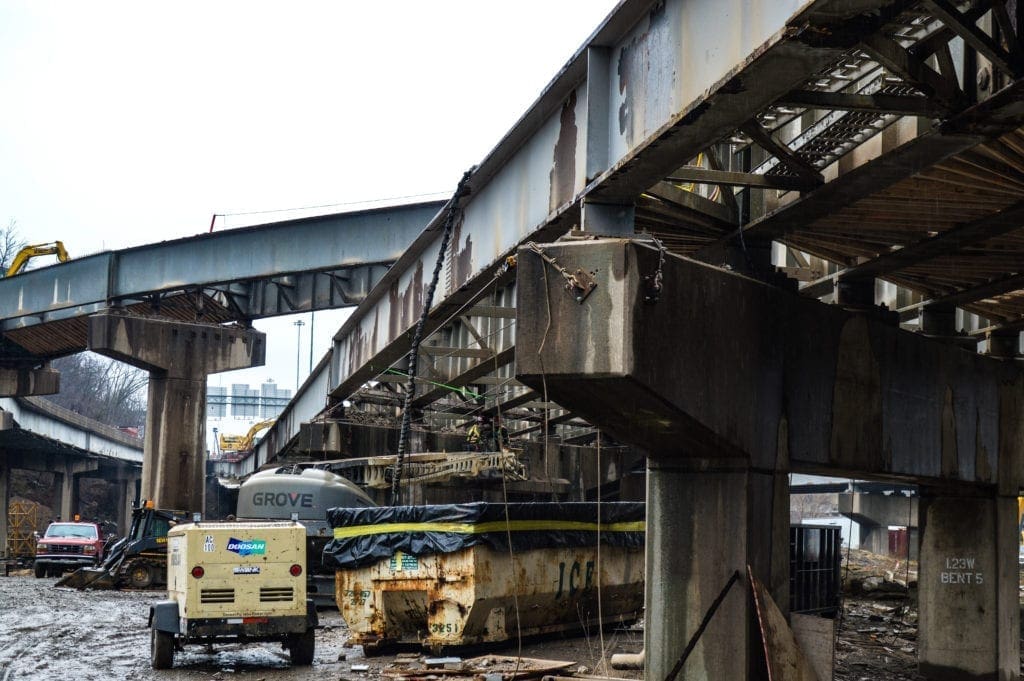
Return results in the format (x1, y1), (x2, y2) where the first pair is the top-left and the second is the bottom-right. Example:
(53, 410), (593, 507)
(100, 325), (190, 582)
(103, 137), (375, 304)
(0, 570), (643, 681)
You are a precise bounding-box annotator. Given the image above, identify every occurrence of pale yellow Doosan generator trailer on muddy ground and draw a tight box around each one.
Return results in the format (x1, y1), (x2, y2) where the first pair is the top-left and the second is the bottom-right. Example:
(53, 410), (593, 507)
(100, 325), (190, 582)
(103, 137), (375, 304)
(150, 522), (317, 669)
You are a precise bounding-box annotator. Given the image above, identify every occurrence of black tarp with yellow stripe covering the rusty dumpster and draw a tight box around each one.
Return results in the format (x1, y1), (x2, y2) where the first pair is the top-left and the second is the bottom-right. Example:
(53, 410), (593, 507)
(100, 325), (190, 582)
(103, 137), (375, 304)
(324, 502), (644, 569)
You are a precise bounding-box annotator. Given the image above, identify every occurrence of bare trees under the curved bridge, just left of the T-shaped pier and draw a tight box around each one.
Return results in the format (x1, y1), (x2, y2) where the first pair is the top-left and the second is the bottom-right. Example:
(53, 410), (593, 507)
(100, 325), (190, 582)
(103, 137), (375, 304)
(49, 352), (150, 426)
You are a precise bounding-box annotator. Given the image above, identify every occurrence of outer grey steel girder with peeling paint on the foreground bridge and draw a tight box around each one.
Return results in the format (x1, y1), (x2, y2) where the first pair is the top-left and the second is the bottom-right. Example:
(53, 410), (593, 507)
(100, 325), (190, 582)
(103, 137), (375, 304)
(331, 0), (888, 400)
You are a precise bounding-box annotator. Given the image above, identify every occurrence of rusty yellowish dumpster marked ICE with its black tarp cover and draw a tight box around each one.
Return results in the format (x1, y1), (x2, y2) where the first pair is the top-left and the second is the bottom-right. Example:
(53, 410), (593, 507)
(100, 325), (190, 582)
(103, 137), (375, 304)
(324, 503), (644, 653)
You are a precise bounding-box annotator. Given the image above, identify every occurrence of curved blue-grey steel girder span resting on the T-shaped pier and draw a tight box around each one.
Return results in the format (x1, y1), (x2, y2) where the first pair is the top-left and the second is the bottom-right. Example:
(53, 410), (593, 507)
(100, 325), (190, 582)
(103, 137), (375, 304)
(0, 202), (442, 370)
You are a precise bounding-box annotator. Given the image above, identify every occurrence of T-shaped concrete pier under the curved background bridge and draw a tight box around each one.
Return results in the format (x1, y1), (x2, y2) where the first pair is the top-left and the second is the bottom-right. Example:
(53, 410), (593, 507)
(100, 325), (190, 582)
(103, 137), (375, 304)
(89, 312), (266, 511)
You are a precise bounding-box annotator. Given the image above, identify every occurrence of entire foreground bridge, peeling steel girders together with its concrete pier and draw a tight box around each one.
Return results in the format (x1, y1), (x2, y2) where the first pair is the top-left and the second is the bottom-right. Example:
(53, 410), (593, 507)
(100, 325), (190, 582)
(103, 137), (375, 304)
(247, 0), (1024, 679)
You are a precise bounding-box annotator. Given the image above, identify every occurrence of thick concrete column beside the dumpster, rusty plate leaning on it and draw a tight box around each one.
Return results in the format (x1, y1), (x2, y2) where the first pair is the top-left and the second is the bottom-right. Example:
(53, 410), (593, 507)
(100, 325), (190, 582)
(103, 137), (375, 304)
(644, 457), (790, 680)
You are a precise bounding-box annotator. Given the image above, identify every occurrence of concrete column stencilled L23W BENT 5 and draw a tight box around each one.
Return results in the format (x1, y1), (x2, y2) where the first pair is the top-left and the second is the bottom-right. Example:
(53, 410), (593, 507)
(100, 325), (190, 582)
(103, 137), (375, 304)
(918, 491), (1020, 681)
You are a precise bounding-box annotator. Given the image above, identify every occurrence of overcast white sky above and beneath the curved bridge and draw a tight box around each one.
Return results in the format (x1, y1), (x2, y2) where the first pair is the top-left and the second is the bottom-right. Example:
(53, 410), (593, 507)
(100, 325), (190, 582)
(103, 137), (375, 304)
(0, 0), (616, 395)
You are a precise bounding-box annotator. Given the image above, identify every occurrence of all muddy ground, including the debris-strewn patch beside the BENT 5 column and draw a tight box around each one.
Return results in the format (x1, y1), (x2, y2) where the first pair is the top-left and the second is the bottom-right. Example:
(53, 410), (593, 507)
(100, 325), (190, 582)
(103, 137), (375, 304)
(0, 571), (970, 681)
